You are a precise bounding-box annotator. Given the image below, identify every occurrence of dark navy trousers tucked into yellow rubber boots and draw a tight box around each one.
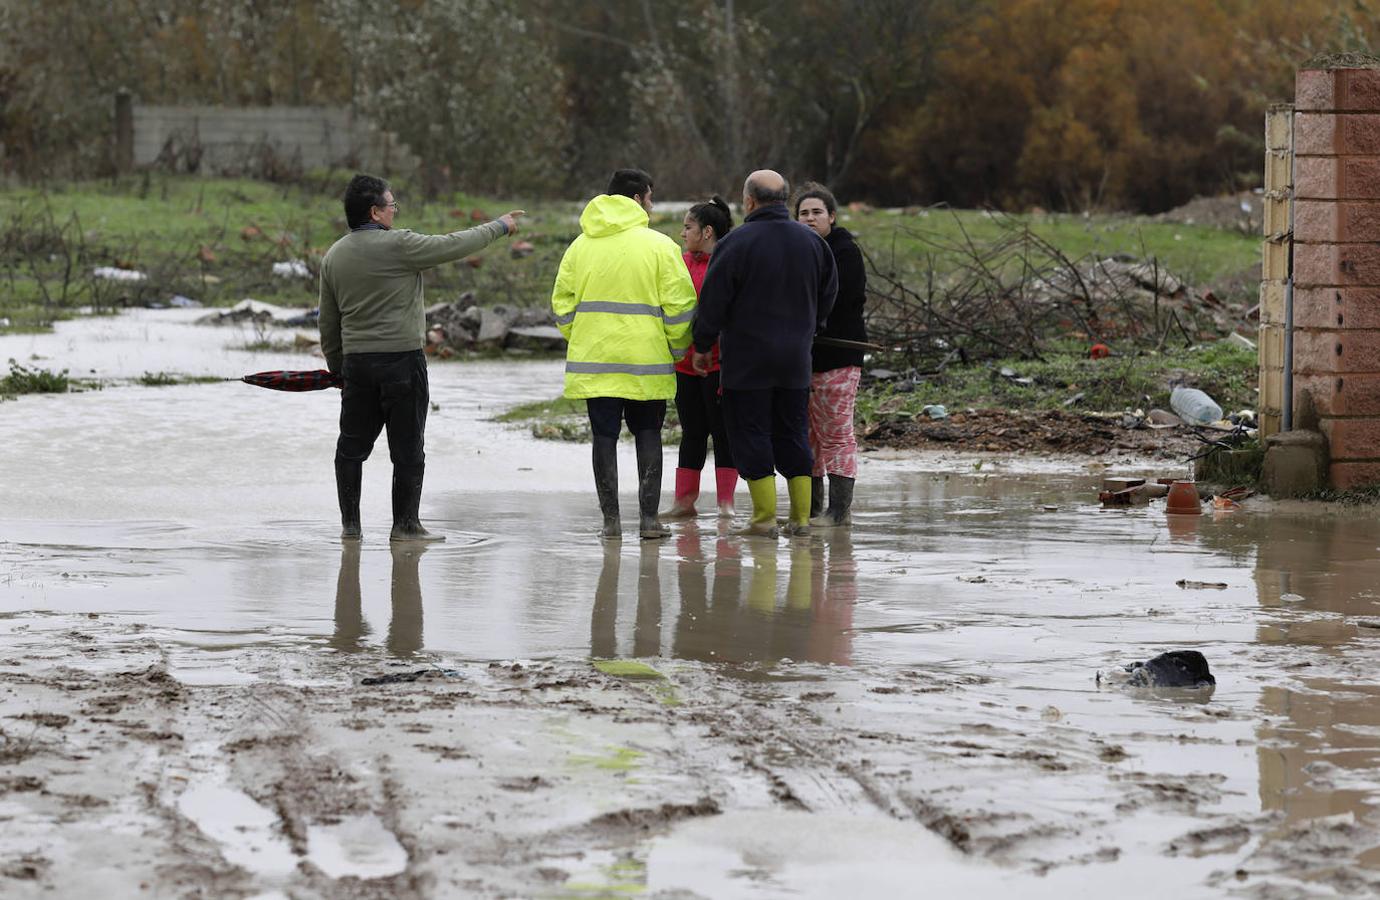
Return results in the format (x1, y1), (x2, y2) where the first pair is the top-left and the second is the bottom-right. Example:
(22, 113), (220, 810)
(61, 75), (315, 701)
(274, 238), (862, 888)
(723, 388), (814, 480)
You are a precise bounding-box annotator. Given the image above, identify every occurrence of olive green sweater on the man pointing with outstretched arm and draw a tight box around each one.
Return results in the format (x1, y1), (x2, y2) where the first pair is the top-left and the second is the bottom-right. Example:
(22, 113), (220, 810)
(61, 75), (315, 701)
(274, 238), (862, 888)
(320, 221), (508, 371)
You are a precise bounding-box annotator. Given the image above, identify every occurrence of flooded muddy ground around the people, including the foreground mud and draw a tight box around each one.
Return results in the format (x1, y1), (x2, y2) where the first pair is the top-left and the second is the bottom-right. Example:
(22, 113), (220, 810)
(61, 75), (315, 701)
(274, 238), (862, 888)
(0, 311), (1380, 897)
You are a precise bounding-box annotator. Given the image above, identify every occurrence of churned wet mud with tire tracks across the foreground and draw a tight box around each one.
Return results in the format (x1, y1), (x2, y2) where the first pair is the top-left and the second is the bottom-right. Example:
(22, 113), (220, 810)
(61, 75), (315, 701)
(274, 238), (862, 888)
(8, 626), (1380, 900)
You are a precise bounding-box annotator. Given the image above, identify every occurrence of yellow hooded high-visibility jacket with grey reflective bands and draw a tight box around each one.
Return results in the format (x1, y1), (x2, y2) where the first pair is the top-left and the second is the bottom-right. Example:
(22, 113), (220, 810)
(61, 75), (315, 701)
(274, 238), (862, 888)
(551, 193), (696, 400)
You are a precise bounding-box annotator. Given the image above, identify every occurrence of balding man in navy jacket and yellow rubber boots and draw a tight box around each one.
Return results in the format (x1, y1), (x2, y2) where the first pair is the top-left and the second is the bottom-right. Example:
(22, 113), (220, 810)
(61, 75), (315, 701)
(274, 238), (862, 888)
(694, 170), (839, 537)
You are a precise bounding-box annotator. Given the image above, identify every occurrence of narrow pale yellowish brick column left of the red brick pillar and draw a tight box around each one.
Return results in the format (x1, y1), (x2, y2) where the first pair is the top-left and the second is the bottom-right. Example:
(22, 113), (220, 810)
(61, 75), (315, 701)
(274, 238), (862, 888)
(1257, 104), (1293, 439)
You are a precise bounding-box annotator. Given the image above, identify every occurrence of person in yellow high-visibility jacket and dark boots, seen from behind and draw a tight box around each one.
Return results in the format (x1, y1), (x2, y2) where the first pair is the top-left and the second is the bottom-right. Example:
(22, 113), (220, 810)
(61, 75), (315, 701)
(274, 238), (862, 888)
(551, 168), (696, 540)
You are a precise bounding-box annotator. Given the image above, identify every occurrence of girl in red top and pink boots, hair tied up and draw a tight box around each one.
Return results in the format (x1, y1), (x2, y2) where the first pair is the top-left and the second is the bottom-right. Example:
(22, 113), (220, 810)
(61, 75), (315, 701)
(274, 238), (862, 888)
(662, 195), (738, 519)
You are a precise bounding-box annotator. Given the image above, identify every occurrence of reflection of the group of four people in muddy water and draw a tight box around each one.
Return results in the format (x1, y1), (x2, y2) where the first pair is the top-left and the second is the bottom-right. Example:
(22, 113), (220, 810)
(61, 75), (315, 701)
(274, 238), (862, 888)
(589, 527), (857, 665)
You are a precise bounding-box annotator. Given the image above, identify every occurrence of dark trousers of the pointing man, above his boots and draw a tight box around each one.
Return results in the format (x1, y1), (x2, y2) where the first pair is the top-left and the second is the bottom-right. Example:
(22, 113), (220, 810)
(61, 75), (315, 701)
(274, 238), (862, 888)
(335, 351), (431, 468)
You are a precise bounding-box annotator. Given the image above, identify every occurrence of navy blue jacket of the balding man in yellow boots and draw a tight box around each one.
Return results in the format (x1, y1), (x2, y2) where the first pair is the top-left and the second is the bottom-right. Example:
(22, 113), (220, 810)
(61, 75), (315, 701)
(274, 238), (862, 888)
(694, 204), (839, 391)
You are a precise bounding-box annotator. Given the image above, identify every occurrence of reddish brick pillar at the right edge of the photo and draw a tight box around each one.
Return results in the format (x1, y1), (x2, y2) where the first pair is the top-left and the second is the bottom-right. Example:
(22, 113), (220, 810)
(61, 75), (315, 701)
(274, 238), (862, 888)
(1293, 69), (1380, 487)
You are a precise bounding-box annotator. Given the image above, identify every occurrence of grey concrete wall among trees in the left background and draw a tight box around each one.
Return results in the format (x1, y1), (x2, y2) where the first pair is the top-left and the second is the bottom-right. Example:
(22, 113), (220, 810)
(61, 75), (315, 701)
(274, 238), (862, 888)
(131, 105), (417, 174)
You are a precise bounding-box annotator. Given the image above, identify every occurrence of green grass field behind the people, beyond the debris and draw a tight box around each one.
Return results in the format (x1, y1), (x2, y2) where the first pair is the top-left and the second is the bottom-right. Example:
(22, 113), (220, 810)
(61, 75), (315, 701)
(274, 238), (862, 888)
(0, 173), (1260, 333)
